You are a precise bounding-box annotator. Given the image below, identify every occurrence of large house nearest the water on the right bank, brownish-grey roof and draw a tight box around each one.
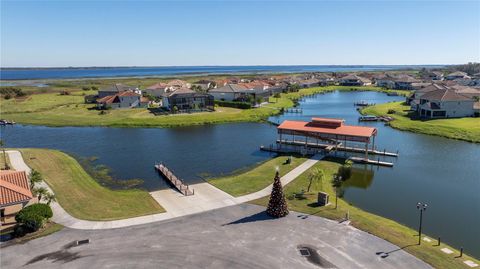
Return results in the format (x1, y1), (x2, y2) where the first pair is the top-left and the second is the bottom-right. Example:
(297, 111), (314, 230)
(417, 88), (475, 119)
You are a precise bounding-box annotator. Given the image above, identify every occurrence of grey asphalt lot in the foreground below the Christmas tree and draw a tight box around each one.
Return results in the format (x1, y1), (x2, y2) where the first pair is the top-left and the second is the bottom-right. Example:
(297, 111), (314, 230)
(0, 204), (430, 269)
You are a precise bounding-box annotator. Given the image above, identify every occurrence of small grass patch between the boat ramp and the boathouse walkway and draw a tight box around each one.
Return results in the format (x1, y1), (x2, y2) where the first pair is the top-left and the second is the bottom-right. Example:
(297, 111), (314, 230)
(208, 156), (307, 197)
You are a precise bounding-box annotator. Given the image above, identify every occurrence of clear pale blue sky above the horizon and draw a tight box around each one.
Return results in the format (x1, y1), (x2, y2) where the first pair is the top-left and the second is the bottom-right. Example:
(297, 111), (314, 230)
(0, 0), (480, 67)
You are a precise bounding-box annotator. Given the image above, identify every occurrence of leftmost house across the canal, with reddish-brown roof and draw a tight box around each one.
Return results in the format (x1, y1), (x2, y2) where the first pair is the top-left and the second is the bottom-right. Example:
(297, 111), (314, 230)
(97, 91), (148, 109)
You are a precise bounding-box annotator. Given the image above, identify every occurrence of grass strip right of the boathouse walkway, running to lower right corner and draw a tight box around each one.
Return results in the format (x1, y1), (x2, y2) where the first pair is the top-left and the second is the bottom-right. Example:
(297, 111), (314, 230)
(251, 160), (479, 268)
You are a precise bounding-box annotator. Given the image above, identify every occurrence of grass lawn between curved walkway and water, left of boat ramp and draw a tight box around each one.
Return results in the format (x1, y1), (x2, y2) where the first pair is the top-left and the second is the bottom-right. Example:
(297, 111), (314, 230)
(20, 149), (165, 220)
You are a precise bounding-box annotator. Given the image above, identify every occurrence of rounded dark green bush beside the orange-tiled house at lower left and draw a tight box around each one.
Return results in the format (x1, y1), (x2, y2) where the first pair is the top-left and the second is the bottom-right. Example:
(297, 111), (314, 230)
(15, 204), (53, 232)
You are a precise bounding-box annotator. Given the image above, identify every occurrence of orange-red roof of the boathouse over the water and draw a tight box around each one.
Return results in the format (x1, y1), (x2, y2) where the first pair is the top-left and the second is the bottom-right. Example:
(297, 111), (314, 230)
(278, 118), (377, 138)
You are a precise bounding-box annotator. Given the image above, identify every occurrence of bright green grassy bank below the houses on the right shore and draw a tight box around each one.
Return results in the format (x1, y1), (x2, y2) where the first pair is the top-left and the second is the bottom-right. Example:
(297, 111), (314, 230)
(361, 102), (480, 143)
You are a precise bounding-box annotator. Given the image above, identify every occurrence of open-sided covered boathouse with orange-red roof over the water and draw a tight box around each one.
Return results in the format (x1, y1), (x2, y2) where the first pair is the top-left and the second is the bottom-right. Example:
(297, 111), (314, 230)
(277, 118), (377, 160)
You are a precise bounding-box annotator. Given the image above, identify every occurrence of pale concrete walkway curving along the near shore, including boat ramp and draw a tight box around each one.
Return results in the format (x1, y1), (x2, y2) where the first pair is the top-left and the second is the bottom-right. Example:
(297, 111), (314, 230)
(7, 150), (319, 230)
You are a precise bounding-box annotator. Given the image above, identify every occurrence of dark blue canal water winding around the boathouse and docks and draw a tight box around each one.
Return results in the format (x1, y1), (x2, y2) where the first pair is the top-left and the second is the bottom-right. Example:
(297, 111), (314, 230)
(1, 92), (480, 257)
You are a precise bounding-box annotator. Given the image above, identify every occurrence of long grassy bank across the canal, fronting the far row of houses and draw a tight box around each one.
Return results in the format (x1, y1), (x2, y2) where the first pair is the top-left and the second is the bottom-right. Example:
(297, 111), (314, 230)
(2, 86), (404, 127)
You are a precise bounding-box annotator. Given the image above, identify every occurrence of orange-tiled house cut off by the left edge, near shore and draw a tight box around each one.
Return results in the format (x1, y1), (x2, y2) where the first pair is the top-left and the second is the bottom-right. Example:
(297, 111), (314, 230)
(0, 170), (37, 232)
